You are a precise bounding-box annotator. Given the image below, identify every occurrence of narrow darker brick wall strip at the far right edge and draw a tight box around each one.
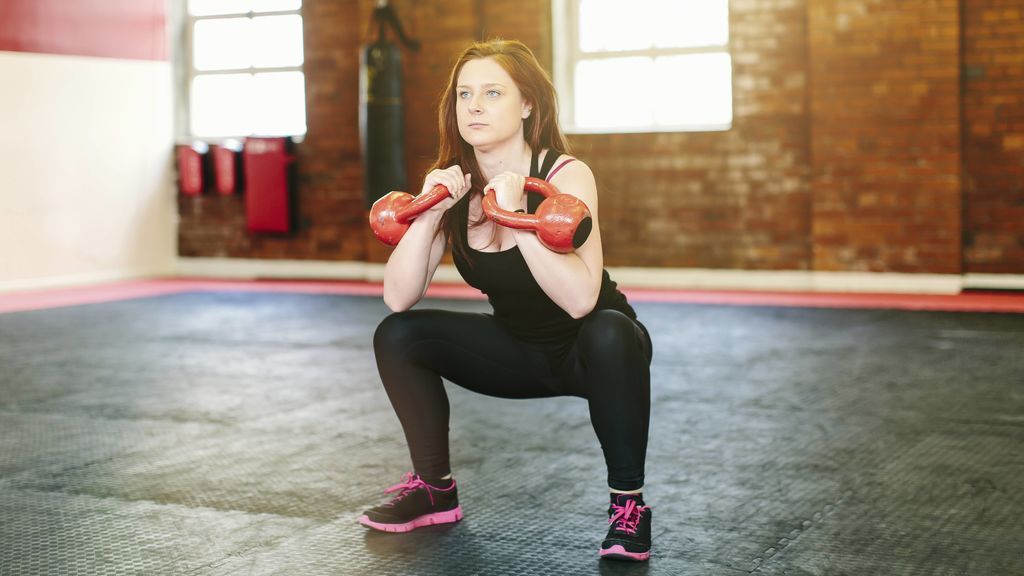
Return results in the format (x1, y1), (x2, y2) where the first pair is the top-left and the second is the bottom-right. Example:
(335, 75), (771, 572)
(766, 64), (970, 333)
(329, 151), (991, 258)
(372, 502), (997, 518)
(964, 0), (1024, 274)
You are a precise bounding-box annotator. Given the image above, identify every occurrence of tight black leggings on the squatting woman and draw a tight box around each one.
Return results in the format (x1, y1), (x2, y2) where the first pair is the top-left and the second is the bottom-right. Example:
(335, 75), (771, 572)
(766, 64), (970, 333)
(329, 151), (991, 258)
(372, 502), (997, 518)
(374, 310), (651, 490)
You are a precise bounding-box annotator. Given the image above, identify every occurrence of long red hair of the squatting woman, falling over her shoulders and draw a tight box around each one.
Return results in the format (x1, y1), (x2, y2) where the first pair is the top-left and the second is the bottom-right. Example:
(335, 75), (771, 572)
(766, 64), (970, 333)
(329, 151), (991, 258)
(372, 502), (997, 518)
(430, 39), (569, 260)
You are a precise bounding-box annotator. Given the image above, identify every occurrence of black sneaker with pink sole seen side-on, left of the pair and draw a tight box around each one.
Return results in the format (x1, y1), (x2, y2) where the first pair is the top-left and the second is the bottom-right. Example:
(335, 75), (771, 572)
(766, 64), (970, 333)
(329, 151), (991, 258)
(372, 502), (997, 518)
(359, 472), (462, 532)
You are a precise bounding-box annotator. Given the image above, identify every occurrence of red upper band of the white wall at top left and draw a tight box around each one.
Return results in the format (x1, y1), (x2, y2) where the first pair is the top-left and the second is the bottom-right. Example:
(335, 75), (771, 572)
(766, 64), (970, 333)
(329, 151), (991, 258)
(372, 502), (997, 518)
(0, 0), (168, 60)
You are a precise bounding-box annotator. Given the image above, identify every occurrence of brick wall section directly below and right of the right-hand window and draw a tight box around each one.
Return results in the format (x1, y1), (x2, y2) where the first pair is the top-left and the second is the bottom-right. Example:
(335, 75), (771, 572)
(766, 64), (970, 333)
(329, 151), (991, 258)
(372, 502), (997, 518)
(572, 0), (810, 270)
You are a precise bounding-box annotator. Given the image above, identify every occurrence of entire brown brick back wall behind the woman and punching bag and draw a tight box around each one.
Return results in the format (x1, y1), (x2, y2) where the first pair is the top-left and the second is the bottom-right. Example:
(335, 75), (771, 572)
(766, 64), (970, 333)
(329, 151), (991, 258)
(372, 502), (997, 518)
(180, 0), (1024, 274)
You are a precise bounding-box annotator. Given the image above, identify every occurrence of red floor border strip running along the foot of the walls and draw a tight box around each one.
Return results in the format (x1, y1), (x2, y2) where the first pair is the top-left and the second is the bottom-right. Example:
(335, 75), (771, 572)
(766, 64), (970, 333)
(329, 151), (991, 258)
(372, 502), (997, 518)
(0, 278), (1024, 314)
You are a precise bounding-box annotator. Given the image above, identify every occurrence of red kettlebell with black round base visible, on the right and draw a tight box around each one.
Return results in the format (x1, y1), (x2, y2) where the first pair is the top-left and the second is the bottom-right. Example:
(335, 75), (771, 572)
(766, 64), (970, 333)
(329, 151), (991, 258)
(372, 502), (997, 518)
(483, 178), (594, 254)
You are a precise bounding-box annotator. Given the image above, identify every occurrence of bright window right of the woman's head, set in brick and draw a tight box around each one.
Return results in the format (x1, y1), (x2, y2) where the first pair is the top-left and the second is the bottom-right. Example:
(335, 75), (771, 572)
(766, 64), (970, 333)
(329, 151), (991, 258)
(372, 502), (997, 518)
(552, 0), (732, 133)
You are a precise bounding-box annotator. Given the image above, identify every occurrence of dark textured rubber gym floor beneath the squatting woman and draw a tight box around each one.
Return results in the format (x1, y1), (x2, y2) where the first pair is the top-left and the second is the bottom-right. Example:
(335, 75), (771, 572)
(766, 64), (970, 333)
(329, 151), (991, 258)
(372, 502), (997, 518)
(0, 283), (1024, 576)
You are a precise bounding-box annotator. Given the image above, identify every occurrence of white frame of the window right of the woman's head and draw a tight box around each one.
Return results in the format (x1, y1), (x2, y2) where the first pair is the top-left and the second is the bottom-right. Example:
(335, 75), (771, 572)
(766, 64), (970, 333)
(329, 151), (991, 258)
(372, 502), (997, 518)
(551, 0), (736, 134)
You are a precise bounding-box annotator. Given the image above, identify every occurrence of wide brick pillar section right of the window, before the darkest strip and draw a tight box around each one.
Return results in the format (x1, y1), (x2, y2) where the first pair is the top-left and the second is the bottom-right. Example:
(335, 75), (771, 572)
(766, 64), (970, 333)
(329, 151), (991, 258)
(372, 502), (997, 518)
(808, 0), (962, 274)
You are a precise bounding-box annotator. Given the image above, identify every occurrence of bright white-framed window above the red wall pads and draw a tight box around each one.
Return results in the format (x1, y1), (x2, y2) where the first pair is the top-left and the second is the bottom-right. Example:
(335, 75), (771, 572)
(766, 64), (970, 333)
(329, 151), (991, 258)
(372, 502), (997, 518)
(187, 0), (306, 138)
